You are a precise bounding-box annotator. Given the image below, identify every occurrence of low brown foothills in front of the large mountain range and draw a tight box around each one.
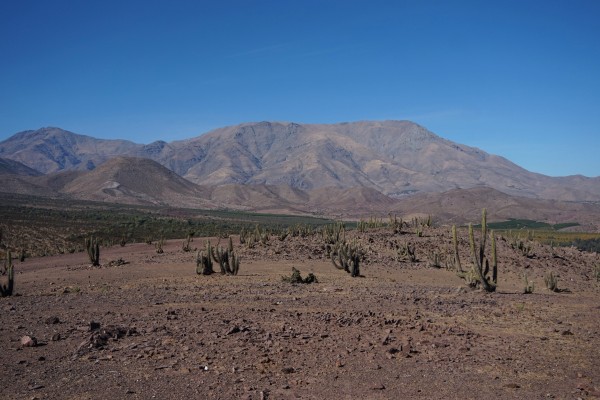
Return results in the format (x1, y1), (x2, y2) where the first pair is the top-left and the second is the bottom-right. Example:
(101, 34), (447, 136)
(0, 157), (600, 231)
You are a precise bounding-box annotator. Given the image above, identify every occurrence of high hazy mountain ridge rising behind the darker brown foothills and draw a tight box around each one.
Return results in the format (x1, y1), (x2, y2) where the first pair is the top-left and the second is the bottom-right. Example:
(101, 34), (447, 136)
(0, 121), (600, 201)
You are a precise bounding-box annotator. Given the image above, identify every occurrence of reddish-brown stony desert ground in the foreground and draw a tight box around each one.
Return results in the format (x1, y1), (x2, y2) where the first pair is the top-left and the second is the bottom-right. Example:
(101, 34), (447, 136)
(0, 227), (600, 400)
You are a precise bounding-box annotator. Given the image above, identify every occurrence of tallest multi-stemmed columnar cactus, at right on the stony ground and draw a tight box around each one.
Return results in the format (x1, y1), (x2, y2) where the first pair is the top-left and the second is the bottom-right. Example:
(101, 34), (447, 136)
(469, 208), (498, 292)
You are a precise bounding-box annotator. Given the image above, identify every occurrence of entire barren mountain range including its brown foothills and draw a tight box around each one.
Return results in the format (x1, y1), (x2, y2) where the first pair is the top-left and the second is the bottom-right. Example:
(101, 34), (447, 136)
(0, 121), (600, 226)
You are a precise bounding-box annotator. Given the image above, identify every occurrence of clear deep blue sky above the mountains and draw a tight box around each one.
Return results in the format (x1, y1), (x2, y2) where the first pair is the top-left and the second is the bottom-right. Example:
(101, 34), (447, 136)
(0, 0), (600, 176)
